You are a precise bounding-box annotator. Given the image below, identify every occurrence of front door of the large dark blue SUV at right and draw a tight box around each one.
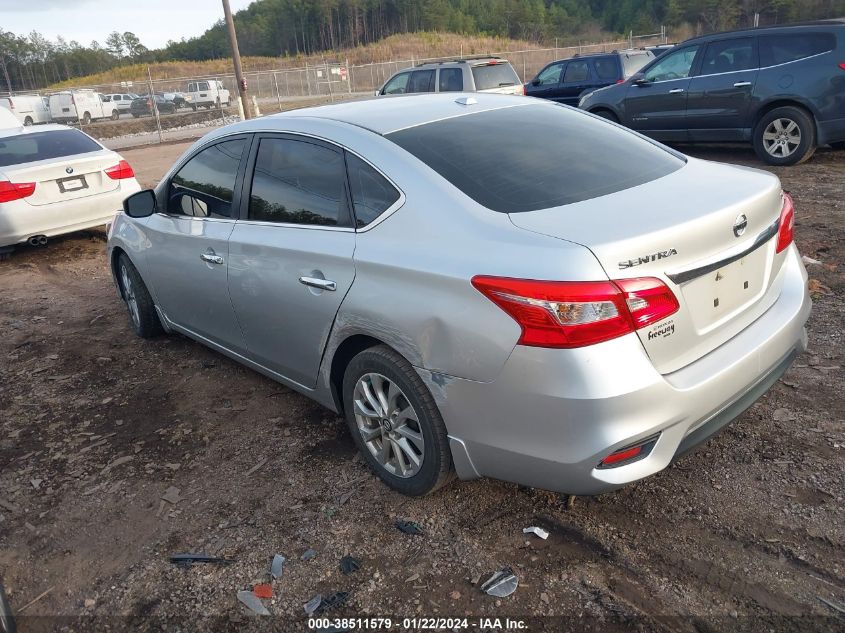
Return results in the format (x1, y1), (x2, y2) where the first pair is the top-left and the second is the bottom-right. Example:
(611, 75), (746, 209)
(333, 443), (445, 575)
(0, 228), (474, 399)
(624, 44), (700, 141)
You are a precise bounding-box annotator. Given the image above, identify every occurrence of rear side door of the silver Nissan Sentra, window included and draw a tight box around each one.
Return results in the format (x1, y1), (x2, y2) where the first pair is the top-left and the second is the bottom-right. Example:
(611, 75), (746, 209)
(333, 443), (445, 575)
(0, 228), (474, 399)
(229, 135), (355, 388)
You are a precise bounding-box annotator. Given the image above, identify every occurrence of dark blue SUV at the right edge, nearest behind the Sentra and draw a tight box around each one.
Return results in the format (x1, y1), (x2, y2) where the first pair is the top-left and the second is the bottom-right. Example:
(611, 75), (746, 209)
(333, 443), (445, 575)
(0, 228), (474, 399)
(579, 19), (845, 165)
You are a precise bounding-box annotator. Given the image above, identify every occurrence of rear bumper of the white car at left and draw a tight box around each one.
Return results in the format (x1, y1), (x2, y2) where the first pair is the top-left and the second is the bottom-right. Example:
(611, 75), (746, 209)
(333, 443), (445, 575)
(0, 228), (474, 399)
(0, 178), (141, 246)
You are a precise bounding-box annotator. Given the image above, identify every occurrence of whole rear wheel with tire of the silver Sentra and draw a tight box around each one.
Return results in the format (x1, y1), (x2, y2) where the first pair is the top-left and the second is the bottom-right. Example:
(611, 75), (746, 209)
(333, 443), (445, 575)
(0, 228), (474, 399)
(343, 345), (452, 497)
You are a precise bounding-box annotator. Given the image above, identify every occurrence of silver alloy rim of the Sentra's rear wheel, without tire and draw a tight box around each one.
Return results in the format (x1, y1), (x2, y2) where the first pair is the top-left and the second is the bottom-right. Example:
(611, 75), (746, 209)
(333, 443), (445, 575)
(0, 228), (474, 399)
(352, 373), (425, 478)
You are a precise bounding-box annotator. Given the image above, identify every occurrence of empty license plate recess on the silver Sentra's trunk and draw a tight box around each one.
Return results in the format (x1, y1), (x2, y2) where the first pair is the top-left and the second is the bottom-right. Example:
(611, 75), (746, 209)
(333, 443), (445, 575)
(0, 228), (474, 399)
(682, 248), (769, 333)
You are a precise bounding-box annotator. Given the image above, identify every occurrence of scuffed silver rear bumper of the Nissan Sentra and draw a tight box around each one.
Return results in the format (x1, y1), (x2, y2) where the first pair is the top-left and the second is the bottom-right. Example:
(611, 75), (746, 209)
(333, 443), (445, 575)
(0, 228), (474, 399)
(420, 246), (810, 495)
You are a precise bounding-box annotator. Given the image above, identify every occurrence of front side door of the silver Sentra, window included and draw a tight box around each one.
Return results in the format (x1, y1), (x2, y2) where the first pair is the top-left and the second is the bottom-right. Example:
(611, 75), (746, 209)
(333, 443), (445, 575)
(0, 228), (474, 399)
(144, 136), (249, 352)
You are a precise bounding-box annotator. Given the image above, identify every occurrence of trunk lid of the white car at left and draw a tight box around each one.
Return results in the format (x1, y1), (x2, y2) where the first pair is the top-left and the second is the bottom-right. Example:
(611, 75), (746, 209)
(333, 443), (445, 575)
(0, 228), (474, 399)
(2, 150), (120, 207)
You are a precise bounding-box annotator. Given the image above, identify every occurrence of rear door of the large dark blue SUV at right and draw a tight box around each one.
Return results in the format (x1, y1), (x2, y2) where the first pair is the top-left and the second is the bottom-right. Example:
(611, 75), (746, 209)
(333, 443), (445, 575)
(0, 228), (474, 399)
(686, 37), (759, 141)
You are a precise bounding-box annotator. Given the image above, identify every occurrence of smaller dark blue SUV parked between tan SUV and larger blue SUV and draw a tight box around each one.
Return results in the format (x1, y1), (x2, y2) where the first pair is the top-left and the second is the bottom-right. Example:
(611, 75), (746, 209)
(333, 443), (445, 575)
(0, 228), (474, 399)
(525, 49), (654, 105)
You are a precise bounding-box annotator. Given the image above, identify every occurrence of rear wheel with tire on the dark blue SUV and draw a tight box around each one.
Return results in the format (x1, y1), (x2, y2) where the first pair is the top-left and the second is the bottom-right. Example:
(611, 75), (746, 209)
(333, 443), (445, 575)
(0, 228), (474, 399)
(752, 106), (816, 166)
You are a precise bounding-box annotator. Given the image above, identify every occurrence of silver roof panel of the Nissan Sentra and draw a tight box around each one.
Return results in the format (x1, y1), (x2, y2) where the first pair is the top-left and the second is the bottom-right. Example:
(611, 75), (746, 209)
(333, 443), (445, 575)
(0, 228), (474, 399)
(227, 92), (532, 135)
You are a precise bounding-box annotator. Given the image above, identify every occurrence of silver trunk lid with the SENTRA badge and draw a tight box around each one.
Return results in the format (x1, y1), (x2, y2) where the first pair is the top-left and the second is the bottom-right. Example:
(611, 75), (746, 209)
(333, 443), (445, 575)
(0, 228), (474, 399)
(510, 159), (786, 374)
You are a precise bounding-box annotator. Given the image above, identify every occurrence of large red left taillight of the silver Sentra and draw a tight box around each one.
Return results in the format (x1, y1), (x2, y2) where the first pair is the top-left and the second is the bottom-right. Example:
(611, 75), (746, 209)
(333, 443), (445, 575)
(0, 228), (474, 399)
(472, 276), (678, 348)
